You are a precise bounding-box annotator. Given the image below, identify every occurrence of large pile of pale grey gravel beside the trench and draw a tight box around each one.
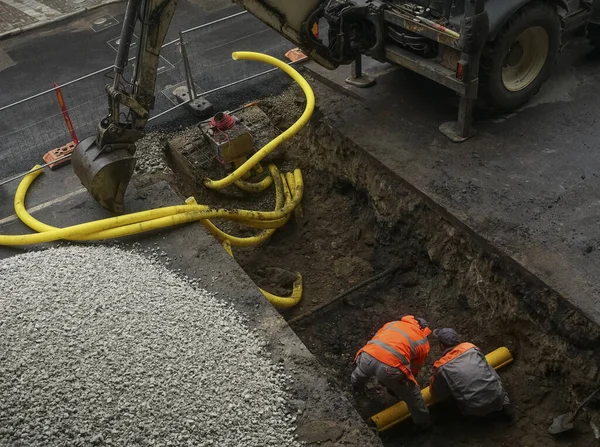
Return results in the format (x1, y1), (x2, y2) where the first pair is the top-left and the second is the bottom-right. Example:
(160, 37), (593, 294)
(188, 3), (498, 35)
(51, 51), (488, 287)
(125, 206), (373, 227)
(0, 247), (300, 447)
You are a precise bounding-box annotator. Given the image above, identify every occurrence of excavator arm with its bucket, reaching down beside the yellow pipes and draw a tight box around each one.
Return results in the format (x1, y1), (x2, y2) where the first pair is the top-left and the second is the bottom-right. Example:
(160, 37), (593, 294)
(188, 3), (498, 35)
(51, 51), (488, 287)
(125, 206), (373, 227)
(71, 0), (177, 214)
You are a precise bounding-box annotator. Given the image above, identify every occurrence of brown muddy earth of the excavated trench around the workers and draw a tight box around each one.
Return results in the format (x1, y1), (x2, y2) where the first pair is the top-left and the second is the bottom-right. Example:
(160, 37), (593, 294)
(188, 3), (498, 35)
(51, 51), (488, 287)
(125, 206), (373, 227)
(135, 85), (600, 447)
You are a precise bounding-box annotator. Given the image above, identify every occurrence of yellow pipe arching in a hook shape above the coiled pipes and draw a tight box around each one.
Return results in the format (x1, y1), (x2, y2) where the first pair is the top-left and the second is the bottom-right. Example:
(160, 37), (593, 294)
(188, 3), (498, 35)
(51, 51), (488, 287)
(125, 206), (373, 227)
(204, 51), (315, 189)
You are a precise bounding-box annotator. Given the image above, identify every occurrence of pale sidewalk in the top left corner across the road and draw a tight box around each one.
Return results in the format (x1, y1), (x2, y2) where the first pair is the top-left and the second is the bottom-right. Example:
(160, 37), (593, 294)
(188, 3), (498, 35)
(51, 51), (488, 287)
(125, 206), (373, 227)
(0, 0), (122, 39)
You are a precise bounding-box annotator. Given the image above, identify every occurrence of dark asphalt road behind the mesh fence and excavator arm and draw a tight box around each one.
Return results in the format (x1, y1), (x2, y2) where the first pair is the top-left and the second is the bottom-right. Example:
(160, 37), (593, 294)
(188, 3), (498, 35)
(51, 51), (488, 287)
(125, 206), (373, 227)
(0, 0), (291, 179)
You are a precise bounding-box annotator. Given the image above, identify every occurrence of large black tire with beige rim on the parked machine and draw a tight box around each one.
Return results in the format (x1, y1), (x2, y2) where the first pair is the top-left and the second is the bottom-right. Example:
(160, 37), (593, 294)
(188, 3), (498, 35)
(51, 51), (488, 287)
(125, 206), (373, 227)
(479, 2), (561, 112)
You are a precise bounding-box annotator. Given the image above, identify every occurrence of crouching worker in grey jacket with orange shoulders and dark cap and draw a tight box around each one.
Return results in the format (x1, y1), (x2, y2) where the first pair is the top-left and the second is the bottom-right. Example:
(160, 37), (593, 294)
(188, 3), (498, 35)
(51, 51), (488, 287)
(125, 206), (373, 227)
(430, 328), (512, 418)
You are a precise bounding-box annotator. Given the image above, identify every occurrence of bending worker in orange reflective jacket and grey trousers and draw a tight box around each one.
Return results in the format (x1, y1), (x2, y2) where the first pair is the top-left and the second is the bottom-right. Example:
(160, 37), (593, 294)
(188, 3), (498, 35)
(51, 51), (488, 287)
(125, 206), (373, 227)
(351, 315), (431, 429)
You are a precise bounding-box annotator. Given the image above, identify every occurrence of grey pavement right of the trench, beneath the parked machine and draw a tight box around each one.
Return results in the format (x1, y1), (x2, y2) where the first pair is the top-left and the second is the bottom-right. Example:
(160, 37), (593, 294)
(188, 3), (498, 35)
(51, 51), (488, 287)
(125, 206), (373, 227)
(304, 41), (600, 324)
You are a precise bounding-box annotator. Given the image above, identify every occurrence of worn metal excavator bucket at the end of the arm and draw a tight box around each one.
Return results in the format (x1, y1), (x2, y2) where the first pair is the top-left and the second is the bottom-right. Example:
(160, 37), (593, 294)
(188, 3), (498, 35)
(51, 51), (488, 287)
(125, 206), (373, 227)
(71, 137), (136, 214)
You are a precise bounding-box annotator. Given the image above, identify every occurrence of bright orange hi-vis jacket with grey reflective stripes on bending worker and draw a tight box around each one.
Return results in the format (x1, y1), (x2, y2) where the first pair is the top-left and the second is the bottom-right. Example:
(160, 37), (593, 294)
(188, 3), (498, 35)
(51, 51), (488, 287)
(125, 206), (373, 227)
(355, 315), (431, 383)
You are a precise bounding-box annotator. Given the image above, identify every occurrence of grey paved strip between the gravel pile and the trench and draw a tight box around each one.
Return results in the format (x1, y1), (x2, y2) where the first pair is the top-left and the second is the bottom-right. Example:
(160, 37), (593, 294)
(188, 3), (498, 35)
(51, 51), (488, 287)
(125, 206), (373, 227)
(0, 167), (381, 447)
